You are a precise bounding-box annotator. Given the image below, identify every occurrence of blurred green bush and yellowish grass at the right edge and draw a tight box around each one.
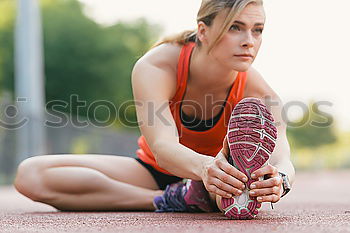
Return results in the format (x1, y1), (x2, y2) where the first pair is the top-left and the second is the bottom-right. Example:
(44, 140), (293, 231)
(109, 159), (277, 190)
(287, 101), (350, 170)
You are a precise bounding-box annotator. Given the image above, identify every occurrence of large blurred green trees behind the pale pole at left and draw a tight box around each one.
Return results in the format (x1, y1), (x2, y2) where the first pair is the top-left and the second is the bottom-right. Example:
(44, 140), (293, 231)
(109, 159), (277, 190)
(0, 0), (161, 129)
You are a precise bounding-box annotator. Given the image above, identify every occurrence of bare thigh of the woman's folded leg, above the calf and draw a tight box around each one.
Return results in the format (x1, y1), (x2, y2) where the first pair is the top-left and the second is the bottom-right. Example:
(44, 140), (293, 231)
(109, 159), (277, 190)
(26, 154), (159, 190)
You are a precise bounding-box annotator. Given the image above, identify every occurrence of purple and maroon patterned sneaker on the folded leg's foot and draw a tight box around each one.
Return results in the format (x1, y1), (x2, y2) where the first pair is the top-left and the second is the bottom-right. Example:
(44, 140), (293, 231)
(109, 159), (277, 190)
(153, 180), (212, 212)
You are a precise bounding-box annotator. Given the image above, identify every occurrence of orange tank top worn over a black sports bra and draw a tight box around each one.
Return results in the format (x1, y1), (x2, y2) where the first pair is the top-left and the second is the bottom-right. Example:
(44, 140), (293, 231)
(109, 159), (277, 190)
(136, 42), (246, 175)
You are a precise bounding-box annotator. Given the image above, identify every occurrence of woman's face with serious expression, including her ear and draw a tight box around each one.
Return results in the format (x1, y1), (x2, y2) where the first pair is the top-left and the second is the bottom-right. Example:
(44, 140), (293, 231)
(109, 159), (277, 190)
(202, 4), (265, 72)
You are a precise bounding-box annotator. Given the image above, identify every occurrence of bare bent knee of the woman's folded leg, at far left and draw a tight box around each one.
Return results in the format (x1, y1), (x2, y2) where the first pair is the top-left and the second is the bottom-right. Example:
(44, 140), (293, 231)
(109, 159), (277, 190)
(14, 156), (52, 201)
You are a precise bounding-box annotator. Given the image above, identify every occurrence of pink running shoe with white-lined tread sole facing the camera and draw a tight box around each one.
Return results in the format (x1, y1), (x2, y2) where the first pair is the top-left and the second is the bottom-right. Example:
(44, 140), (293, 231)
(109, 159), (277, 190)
(221, 98), (277, 219)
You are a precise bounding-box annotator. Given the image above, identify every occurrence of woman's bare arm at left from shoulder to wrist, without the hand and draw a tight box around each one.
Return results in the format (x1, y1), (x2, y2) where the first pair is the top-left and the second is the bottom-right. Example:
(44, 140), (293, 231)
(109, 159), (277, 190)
(132, 59), (204, 180)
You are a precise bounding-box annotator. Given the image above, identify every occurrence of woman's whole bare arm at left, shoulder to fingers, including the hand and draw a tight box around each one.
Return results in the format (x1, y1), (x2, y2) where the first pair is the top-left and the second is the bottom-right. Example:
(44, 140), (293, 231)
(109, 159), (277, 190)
(132, 52), (245, 197)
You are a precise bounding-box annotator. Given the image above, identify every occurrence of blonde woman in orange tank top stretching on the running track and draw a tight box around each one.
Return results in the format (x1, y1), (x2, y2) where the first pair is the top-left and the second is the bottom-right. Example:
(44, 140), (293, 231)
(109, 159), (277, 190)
(15, 0), (295, 218)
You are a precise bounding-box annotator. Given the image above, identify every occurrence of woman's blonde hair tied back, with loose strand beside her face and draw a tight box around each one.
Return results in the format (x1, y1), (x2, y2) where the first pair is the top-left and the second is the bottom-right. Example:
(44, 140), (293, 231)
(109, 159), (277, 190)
(152, 0), (263, 51)
